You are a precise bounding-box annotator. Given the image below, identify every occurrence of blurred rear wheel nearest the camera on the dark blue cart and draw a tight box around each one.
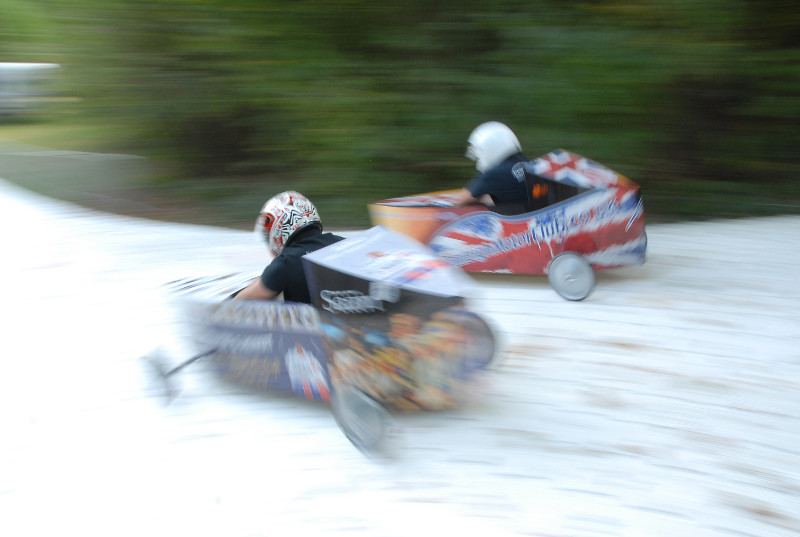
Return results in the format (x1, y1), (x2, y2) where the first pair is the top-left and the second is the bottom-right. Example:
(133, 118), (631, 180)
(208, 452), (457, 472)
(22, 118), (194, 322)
(331, 387), (389, 454)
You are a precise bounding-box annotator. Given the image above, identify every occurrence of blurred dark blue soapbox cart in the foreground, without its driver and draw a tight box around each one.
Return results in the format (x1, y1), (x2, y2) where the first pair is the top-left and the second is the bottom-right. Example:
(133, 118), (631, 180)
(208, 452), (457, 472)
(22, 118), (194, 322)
(145, 227), (495, 453)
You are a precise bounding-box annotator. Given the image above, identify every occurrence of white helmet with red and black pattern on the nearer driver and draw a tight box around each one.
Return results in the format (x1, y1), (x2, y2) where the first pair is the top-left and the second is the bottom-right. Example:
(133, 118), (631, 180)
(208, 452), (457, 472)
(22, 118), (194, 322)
(256, 190), (322, 255)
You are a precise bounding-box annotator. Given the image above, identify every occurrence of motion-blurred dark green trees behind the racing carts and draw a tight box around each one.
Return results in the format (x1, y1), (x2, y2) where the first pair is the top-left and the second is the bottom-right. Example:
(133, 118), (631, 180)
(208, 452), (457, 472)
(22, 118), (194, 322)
(0, 0), (800, 225)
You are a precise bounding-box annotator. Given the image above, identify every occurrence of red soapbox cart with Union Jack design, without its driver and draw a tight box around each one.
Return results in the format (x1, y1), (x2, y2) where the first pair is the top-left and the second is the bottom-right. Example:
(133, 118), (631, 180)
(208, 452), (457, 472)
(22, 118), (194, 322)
(368, 150), (647, 300)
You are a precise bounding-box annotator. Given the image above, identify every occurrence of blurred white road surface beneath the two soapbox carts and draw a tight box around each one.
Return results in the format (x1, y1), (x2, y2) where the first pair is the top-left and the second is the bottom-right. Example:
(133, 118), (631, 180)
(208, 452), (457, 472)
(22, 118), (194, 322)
(0, 174), (800, 537)
